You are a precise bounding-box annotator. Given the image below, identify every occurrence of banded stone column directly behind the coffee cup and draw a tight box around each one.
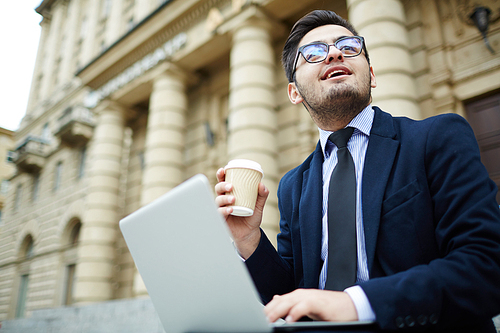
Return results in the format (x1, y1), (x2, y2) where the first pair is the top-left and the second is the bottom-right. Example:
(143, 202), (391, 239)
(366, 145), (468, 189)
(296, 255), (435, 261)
(228, 8), (279, 241)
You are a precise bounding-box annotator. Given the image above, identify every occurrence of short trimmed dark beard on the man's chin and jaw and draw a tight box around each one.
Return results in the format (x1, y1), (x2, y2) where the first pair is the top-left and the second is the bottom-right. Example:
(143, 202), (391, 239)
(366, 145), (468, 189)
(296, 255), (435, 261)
(295, 72), (371, 127)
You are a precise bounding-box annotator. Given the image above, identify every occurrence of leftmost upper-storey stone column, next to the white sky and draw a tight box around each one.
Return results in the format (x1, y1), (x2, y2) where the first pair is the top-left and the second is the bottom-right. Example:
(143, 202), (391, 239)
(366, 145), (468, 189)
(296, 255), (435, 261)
(40, 4), (66, 99)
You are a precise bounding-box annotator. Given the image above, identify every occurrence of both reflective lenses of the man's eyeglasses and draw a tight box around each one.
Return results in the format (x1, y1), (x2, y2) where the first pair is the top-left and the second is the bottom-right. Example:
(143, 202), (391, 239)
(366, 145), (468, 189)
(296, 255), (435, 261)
(301, 38), (363, 62)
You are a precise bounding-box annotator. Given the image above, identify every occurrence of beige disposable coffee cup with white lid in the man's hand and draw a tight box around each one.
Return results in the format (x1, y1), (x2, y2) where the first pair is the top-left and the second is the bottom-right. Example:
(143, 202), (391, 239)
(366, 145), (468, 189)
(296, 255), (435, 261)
(224, 159), (264, 216)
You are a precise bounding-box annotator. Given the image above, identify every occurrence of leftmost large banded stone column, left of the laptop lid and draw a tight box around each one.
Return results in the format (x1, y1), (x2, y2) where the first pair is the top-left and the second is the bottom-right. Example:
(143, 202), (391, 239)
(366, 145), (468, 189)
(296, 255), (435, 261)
(74, 101), (125, 304)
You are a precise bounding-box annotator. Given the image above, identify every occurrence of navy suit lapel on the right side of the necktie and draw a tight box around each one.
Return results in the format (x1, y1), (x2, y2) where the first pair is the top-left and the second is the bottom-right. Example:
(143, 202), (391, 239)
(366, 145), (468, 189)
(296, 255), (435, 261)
(362, 107), (399, 272)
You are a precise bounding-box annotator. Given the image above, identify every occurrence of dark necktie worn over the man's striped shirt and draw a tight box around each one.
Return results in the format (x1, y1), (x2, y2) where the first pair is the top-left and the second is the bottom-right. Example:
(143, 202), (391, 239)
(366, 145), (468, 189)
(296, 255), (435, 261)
(325, 127), (357, 291)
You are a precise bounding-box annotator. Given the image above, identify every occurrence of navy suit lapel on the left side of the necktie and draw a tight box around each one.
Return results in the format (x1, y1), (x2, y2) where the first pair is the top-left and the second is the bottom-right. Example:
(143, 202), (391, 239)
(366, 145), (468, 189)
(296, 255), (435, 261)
(299, 143), (323, 288)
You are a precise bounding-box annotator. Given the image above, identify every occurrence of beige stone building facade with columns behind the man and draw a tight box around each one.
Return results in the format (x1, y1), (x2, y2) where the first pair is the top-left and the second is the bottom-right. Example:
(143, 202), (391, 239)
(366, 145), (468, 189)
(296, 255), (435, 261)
(0, 0), (500, 320)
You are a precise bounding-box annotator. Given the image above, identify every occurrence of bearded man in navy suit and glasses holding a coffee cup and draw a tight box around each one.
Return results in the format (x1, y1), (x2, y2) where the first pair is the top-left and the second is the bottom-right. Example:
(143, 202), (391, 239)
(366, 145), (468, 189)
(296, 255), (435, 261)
(215, 11), (500, 332)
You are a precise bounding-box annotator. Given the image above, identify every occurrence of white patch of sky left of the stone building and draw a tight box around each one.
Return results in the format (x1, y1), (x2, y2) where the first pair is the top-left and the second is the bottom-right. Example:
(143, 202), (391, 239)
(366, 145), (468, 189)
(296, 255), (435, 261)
(0, 0), (42, 131)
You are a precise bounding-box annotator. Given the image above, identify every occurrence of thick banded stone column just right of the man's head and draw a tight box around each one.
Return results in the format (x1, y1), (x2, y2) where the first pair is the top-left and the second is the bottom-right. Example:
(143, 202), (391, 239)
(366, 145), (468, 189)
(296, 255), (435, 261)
(347, 0), (421, 119)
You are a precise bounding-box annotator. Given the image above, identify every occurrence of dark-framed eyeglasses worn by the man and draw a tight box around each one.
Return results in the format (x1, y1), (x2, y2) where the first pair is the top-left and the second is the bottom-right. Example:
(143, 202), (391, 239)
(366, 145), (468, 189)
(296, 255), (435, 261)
(292, 36), (365, 77)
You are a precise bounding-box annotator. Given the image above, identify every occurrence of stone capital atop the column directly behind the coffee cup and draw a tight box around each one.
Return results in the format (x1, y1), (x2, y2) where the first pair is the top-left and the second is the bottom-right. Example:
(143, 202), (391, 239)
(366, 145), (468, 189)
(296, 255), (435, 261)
(215, 4), (286, 37)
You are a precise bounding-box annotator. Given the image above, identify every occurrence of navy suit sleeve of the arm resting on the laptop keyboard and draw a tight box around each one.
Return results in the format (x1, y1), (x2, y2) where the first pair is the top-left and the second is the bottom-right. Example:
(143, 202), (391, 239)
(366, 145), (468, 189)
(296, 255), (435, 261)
(360, 115), (500, 330)
